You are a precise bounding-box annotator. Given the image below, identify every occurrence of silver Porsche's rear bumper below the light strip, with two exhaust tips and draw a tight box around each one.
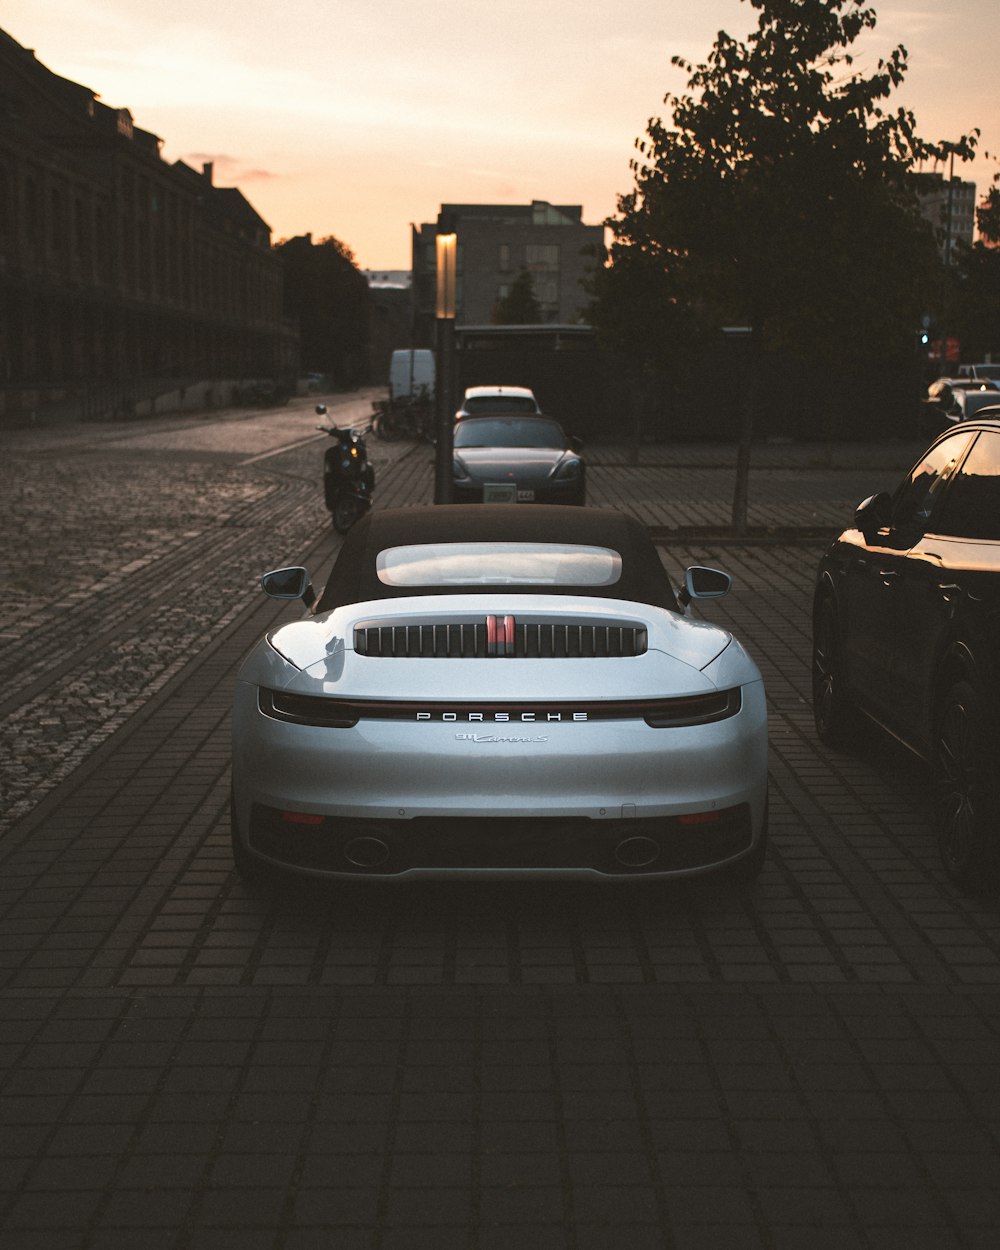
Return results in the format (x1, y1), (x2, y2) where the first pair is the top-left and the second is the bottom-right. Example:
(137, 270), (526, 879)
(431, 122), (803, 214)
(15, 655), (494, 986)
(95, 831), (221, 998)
(233, 683), (768, 878)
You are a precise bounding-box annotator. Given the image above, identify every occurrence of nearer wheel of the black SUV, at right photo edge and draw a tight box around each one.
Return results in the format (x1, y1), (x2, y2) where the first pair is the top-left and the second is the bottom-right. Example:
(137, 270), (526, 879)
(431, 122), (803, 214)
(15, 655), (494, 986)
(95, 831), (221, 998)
(934, 676), (1000, 889)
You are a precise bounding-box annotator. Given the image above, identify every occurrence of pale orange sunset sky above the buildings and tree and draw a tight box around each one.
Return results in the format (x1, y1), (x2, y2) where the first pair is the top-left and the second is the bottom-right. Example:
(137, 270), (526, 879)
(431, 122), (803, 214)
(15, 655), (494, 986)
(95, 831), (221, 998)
(7, 0), (1000, 269)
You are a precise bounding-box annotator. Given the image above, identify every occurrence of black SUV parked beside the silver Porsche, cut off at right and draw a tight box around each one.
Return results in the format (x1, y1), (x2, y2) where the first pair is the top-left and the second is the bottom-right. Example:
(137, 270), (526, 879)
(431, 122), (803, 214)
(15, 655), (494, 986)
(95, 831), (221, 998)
(813, 420), (1000, 888)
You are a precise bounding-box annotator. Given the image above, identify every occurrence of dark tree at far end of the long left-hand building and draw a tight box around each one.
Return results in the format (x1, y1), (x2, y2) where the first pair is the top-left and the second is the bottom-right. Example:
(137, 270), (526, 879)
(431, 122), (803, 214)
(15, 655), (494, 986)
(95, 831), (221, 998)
(275, 235), (369, 389)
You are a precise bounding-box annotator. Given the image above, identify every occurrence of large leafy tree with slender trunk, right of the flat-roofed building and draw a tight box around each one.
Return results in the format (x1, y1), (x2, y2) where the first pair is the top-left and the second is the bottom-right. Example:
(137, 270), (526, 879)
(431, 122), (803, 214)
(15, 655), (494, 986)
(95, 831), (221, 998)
(595, 0), (975, 529)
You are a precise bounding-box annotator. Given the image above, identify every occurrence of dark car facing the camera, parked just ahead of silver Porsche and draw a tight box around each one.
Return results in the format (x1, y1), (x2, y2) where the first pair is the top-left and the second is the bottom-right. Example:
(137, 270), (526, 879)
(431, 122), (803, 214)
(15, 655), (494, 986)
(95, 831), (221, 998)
(453, 416), (586, 504)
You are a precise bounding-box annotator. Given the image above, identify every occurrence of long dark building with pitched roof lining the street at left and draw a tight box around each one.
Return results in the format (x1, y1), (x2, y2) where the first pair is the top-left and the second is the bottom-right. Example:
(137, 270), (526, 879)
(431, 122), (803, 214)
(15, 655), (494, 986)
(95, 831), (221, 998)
(0, 31), (298, 421)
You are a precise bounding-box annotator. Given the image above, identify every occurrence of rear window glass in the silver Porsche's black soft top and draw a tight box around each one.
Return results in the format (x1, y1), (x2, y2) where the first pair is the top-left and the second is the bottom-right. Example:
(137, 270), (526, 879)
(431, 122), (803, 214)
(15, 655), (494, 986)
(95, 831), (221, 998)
(375, 543), (621, 588)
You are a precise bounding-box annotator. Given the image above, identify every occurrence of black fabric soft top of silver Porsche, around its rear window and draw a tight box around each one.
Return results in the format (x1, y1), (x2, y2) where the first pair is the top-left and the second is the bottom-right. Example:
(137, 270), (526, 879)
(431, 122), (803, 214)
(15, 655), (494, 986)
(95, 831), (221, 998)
(314, 504), (678, 613)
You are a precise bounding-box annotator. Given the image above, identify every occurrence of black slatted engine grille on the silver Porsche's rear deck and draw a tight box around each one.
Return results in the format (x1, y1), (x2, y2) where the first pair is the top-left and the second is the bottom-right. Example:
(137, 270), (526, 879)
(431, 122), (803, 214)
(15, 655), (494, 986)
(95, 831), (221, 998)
(354, 618), (648, 660)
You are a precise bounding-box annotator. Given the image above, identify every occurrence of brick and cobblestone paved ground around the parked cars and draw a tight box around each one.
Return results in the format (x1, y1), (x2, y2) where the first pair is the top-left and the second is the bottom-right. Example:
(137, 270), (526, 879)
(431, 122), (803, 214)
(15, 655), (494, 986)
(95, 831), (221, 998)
(0, 410), (1000, 1250)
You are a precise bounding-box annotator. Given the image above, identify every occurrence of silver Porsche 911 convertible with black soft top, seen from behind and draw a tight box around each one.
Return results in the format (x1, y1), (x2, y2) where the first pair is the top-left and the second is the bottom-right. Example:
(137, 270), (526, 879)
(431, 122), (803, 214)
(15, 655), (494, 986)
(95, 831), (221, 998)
(233, 504), (768, 880)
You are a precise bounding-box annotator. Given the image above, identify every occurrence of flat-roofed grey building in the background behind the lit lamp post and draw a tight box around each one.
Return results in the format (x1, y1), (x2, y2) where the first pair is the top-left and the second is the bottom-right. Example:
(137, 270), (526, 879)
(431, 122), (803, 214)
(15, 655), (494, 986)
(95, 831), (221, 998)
(413, 200), (604, 346)
